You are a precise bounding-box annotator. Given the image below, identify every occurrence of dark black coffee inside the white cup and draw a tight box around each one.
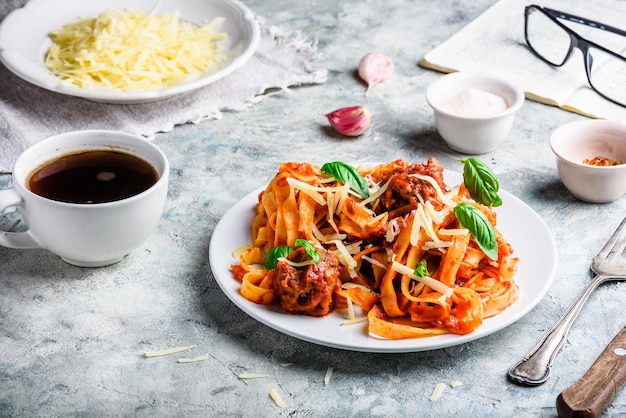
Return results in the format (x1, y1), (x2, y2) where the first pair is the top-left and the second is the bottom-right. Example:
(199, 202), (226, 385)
(27, 150), (159, 203)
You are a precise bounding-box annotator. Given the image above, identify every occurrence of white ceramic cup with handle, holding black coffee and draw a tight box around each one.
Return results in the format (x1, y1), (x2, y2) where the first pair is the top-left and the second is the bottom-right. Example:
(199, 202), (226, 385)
(0, 130), (169, 267)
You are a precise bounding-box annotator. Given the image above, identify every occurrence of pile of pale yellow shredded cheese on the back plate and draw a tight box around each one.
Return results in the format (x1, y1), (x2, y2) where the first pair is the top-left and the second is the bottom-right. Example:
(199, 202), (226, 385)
(44, 10), (228, 92)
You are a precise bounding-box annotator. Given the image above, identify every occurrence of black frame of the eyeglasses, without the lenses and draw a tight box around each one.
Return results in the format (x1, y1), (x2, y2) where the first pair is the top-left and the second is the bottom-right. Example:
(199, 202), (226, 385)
(524, 5), (626, 107)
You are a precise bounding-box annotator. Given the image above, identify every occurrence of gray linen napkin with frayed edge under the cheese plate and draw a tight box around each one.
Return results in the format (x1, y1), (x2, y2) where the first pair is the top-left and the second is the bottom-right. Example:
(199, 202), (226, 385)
(0, 4), (327, 173)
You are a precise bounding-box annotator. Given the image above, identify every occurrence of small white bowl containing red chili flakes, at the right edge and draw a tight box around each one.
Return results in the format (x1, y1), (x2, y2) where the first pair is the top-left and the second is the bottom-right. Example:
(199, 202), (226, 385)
(550, 120), (626, 203)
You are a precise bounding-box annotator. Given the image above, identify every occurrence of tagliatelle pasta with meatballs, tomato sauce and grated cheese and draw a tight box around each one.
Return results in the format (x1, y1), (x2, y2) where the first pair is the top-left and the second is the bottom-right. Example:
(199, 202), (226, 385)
(231, 158), (519, 339)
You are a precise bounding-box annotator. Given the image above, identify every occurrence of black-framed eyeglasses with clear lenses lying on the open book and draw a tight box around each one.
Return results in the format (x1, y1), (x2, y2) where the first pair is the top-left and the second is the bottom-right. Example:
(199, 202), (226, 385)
(524, 5), (626, 107)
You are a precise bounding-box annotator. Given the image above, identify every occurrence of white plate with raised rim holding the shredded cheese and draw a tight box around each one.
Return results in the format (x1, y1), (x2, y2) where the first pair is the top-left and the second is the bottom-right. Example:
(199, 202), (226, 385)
(0, 0), (260, 103)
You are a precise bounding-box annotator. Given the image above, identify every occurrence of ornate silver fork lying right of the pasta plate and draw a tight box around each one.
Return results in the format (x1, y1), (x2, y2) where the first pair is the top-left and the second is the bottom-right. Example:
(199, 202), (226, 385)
(508, 218), (626, 386)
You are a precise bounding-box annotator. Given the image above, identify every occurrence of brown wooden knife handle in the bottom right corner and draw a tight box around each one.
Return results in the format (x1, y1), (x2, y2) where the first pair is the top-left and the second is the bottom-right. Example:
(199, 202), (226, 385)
(556, 327), (626, 417)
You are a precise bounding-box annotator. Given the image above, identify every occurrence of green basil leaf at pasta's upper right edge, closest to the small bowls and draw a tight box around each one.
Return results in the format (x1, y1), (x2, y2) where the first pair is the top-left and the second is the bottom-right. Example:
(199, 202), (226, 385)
(462, 157), (502, 206)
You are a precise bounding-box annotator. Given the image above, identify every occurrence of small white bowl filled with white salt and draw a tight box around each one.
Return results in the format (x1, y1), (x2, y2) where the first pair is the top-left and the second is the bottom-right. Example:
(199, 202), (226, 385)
(426, 72), (524, 154)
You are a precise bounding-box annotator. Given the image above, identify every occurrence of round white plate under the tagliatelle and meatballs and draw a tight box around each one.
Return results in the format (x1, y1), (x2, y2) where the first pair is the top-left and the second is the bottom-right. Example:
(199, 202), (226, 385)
(209, 171), (557, 353)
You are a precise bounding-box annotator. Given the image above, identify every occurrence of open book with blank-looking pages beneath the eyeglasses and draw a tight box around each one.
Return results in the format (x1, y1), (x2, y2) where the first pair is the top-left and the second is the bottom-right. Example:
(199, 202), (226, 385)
(419, 0), (626, 122)
